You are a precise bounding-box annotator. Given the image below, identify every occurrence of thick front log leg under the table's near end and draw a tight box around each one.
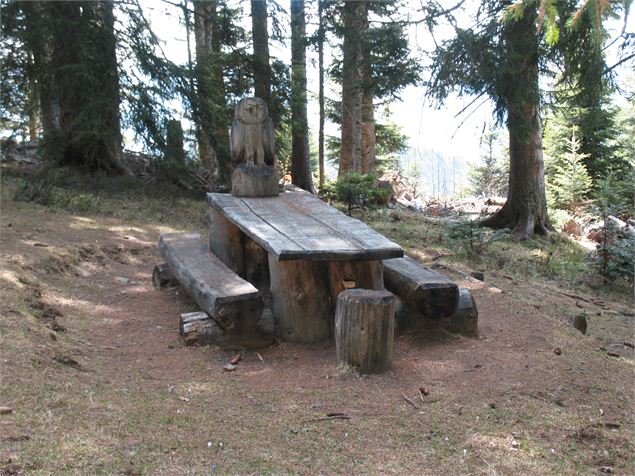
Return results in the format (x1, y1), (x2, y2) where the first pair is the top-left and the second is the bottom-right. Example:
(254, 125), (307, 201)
(269, 255), (332, 343)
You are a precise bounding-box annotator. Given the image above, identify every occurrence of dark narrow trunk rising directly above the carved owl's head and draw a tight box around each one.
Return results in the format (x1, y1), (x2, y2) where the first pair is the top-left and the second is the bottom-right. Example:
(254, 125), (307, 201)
(251, 0), (271, 107)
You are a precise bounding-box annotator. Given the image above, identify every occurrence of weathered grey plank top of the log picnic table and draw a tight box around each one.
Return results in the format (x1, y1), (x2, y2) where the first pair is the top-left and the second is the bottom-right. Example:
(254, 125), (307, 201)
(207, 192), (403, 261)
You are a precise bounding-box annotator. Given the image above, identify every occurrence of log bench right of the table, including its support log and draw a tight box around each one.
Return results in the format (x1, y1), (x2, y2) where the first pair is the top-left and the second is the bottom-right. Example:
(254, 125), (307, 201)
(384, 256), (478, 336)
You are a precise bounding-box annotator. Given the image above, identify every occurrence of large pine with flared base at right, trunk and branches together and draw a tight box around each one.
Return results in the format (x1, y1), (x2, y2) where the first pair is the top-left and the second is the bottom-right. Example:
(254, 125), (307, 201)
(429, 0), (628, 240)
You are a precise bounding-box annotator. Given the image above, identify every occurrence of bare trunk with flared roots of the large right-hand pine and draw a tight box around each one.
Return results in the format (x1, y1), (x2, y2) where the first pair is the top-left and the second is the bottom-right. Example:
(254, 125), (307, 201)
(482, 8), (551, 241)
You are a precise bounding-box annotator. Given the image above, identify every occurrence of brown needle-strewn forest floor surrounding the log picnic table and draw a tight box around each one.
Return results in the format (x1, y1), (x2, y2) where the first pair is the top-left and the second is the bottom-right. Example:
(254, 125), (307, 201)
(0, 166), (635, 475)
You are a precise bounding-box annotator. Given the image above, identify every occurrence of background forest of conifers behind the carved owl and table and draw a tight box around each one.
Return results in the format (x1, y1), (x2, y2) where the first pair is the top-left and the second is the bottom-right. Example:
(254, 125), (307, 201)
(2, 0), (635, 275)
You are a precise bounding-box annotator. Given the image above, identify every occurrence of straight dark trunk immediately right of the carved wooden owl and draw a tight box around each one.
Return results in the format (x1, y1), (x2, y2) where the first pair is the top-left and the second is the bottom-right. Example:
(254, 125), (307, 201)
(291, 0), (315, 193)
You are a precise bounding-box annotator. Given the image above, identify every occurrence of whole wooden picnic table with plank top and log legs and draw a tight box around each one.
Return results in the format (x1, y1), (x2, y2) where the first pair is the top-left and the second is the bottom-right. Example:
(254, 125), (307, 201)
(207, 192), (404, 342)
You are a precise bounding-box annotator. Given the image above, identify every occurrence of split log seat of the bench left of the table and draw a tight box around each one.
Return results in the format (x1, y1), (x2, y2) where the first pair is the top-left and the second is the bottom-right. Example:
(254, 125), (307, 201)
(159, 233), (263, 334)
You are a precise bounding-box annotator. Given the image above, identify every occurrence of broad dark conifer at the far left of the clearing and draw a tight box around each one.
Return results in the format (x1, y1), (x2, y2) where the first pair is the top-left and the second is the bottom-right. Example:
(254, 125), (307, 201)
(19, 0), (126, 173)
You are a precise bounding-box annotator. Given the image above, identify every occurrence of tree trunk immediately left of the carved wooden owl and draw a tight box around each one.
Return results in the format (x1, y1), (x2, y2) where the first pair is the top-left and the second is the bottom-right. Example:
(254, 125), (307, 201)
(193, 1), (231, 184)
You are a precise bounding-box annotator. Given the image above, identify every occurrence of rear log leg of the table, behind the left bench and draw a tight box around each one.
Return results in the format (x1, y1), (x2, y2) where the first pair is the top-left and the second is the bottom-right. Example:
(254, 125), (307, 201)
(209, 207), (245, 278)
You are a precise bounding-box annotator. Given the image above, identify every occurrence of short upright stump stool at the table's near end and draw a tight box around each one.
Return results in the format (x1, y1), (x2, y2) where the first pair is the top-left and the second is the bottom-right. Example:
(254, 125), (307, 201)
(335, 289), (395, 373)
